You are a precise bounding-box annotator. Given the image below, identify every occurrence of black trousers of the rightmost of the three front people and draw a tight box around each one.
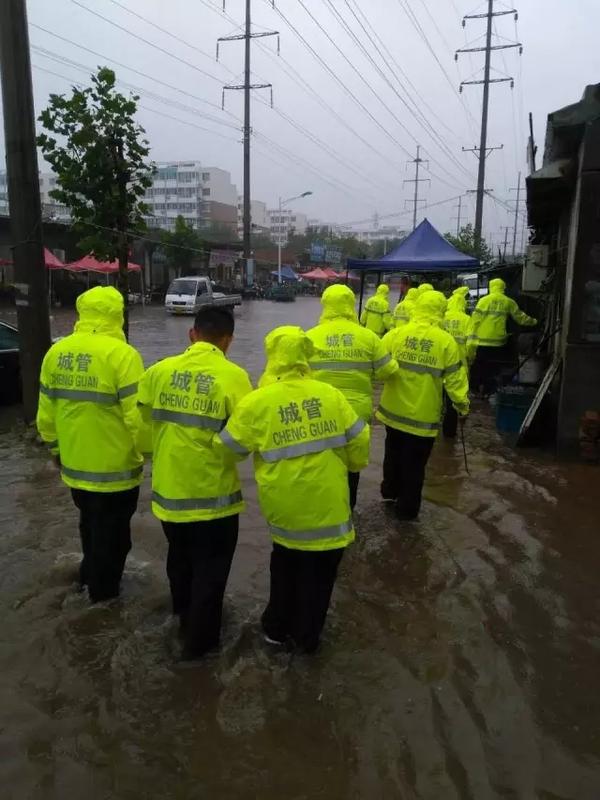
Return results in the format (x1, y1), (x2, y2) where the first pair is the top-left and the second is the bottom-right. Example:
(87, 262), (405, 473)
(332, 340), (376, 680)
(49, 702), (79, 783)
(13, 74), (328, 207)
(262, 544), (344, 653)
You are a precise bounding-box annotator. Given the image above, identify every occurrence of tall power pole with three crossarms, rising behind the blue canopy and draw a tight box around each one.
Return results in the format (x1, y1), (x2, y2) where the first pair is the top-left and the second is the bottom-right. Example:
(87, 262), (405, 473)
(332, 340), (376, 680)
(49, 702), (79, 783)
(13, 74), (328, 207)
(455, 0), (523, 247)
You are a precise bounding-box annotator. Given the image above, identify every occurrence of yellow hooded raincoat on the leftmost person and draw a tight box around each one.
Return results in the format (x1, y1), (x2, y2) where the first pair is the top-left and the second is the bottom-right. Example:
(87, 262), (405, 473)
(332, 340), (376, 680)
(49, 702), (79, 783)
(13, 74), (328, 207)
(37, 286), (144, 492)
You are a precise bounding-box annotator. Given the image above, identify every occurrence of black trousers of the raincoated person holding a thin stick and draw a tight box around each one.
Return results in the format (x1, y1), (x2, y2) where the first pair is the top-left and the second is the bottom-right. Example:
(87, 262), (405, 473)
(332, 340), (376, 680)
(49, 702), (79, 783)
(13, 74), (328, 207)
(381, 426), (435, 519)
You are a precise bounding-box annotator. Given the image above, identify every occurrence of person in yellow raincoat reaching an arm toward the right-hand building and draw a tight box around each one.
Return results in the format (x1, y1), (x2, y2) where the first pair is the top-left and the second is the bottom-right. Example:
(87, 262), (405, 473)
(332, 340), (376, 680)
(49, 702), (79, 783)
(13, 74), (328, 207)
(472, 278), (538, 394)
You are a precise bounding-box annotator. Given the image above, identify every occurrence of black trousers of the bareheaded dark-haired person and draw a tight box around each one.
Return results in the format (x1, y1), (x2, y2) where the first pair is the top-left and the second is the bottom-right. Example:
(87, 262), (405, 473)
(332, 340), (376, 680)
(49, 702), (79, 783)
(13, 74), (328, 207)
(162, 514), (239, 658)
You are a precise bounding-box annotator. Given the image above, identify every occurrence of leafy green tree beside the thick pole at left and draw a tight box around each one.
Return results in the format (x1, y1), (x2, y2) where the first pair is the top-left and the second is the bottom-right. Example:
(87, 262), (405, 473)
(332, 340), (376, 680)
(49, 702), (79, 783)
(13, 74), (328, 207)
(38, 67), (154, 333)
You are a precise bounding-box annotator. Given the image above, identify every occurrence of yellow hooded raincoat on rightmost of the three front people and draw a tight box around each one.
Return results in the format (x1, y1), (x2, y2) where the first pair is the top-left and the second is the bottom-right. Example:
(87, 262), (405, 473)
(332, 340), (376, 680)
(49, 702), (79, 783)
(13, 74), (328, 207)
(214, 326), (369, 550)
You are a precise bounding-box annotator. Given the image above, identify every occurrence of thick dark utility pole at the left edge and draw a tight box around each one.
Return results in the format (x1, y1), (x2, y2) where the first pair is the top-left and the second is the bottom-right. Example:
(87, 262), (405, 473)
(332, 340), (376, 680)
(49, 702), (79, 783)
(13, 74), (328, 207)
(0, 0), (50, 422)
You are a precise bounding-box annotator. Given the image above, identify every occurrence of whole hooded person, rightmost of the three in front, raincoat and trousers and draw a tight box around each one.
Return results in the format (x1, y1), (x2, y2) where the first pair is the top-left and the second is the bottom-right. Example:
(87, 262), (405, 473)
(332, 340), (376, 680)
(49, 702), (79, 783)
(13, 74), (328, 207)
(215, 326), (369, 653)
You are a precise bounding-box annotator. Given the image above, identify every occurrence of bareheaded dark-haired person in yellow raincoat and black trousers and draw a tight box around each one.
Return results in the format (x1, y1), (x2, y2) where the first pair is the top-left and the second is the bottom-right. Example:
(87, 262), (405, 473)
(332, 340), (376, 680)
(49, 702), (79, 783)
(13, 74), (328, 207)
(138, 307), (252, 661)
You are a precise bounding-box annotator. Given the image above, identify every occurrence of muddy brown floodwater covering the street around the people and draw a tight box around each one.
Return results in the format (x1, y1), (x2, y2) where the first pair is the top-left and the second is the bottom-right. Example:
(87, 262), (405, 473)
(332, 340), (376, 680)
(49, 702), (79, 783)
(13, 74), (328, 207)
(0, 298), (600, 800)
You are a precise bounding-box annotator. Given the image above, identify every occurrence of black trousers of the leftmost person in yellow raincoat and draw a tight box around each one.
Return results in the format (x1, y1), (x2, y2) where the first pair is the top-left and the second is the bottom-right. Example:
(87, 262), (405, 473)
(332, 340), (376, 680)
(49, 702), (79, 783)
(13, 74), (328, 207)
(71, 486), (140, 603)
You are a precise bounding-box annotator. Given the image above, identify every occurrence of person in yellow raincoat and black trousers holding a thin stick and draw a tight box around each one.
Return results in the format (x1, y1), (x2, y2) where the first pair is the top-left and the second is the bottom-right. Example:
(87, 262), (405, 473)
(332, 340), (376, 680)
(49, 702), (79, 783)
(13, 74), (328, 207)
(376, 291), (469, 520)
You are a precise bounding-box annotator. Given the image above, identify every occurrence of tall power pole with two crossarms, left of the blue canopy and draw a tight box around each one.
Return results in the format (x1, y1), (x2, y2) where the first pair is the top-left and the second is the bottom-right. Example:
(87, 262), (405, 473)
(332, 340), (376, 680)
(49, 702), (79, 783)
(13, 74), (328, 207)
(217, 0), (279, 284)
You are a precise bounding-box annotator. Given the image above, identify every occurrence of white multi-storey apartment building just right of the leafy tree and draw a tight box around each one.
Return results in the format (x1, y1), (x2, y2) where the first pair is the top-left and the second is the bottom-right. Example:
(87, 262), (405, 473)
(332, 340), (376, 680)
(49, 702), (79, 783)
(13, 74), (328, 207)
(145, 161), (238, 236)
